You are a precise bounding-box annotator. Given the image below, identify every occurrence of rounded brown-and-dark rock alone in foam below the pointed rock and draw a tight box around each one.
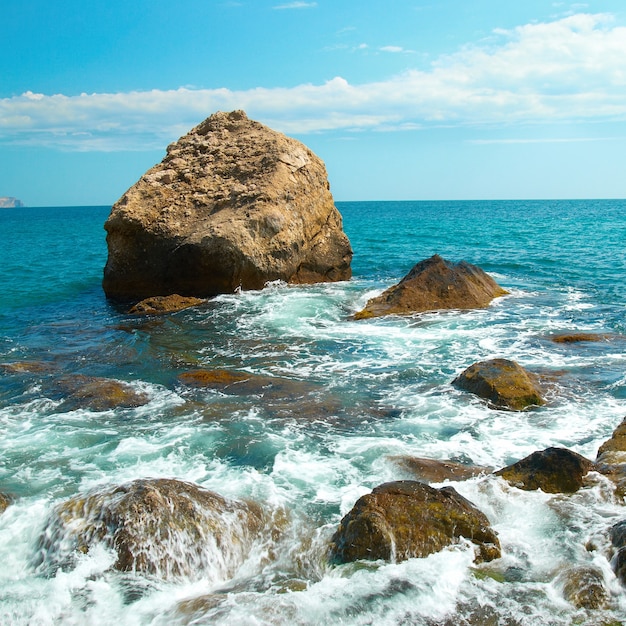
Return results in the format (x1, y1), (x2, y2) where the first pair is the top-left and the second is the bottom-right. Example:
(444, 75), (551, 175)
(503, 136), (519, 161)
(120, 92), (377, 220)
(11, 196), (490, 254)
(452, 359), (545, 411)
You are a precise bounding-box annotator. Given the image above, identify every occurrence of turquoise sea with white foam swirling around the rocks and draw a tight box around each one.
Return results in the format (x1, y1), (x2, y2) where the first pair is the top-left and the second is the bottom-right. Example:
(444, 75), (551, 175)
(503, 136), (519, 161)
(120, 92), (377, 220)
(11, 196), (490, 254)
(0, 200), (626, 626)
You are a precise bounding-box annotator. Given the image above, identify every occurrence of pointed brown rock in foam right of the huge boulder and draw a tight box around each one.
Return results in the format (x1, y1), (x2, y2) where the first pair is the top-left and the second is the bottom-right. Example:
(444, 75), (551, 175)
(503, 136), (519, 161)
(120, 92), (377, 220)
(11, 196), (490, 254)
(354, 254), (507, 319)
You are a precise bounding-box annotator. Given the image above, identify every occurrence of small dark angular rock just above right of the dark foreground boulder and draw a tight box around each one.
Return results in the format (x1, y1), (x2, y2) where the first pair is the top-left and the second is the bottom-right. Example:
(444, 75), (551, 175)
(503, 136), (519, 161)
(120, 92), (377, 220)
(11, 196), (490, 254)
(495, 448), (595, 493)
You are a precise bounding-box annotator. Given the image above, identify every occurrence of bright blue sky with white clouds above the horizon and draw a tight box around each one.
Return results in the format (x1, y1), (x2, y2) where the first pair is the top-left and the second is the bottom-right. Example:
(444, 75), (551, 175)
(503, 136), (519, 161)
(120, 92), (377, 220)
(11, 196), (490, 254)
(0, 0), (626, 206)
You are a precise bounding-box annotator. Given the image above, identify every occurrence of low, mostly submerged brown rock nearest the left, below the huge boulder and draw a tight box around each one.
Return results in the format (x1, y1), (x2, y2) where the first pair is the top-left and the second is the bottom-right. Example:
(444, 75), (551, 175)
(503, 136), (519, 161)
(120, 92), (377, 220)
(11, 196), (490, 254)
(58, 376), (150, 411)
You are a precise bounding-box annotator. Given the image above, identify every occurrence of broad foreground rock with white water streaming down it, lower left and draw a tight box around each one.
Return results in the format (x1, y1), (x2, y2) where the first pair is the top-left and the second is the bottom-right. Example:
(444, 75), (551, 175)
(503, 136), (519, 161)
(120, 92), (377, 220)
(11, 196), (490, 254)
(36, 479), (265, 581)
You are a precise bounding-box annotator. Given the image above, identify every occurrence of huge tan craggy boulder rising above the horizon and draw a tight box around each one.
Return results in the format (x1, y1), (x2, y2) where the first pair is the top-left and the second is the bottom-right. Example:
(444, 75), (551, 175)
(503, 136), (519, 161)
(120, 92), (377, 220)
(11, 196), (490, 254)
(103, 111), (352, 300)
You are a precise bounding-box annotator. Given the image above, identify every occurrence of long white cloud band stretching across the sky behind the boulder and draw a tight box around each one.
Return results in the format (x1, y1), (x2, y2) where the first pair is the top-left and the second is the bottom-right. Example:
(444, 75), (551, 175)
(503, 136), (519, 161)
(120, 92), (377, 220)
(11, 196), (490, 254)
(0, 14), (626, 150)
